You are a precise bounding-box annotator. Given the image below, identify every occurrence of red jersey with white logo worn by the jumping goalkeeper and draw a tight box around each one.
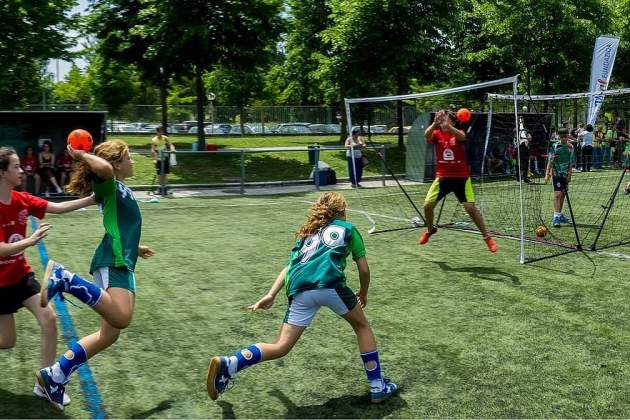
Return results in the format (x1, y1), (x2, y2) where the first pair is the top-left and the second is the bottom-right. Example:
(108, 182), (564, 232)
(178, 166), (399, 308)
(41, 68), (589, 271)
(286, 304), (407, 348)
(428, 129), (469, 178)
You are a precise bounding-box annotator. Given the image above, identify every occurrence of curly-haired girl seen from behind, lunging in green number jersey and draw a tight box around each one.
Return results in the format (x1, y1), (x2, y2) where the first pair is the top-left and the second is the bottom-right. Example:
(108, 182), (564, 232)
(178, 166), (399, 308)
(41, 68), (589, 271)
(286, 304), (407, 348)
(207, 192), (398, 403)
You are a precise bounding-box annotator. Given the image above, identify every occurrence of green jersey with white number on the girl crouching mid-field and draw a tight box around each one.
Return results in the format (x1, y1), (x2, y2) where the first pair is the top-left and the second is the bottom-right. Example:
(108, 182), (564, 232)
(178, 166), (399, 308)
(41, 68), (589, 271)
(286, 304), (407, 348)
(284, 219), (365, 297)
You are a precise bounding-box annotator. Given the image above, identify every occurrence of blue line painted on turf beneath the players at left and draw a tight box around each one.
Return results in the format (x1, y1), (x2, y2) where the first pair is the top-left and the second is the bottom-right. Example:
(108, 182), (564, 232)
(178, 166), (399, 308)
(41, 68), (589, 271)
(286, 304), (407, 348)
(31, 217), (107, 419)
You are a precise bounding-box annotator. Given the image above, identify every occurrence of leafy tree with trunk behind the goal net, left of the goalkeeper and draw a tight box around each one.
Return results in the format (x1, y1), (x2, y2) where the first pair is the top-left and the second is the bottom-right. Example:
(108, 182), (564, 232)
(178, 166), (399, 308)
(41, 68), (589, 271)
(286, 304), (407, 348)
(318, 0), (451, 146)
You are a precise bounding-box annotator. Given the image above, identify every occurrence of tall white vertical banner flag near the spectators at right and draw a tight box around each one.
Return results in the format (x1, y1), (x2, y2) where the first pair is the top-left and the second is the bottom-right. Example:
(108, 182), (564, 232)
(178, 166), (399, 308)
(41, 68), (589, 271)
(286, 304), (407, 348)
(587, 35), (619, 125)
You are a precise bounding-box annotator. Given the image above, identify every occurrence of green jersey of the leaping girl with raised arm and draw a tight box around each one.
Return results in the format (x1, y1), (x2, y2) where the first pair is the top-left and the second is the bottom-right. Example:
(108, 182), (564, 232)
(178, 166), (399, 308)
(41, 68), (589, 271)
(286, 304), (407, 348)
(90, 178), (142, 273)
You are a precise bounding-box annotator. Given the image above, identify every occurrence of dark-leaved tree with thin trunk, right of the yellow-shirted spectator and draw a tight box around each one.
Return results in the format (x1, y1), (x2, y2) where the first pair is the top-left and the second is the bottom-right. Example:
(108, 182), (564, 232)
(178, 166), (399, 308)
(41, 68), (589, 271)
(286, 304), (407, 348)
(161, 0), (282, 150)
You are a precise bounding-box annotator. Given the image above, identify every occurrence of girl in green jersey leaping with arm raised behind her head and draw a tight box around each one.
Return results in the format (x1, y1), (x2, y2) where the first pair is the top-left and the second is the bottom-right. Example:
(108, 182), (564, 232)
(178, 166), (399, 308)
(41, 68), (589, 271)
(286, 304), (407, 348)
(37, 140), (153, 410)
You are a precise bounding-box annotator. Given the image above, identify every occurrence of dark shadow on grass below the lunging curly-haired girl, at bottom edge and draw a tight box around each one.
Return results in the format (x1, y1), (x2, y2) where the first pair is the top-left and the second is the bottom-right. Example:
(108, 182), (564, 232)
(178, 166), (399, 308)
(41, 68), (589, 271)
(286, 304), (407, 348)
(269, 389), (407, 419)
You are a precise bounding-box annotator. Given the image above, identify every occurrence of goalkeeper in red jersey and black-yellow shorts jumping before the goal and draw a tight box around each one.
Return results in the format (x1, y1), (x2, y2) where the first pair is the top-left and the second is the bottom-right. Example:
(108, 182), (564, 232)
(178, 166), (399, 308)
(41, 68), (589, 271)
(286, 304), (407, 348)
(418, 110), (497, 252)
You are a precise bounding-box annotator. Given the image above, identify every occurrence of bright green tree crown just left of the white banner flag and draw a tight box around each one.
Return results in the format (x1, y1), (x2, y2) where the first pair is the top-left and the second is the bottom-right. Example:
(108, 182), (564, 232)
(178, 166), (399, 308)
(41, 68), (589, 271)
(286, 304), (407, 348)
(462, 0), (614, 93)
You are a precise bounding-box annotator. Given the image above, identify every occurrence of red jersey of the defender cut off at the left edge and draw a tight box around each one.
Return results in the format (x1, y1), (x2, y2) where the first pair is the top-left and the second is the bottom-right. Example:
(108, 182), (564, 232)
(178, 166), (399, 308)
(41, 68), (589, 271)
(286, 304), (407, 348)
(0, 191), (48, 287)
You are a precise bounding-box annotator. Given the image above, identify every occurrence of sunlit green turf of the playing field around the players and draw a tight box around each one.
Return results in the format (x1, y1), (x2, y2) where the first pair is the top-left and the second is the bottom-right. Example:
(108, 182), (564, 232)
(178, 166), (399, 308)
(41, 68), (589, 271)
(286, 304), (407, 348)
(0, 194), (630, 418)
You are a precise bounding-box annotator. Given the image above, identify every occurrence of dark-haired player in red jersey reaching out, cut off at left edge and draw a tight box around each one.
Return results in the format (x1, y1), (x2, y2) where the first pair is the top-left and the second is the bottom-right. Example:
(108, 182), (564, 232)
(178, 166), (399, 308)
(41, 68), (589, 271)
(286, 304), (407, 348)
(0, 147), (95, 404)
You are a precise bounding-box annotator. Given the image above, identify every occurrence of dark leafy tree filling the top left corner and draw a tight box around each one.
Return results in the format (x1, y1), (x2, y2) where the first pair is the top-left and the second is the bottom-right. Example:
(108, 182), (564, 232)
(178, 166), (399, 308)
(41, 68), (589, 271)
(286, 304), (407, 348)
(0, 0), (76, 109)
